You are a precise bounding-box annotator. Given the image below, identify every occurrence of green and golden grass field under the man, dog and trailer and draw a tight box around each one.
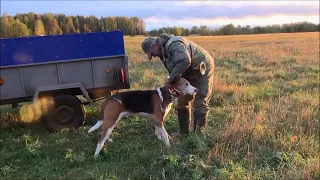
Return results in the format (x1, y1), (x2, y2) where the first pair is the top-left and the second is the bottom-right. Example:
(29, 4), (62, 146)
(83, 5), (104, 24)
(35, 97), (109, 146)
(0, 32), (320, 180)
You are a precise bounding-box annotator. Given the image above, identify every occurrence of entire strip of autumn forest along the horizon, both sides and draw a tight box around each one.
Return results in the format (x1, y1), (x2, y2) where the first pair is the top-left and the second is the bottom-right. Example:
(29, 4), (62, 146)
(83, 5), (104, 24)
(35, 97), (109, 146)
(0, 12), (320, 38)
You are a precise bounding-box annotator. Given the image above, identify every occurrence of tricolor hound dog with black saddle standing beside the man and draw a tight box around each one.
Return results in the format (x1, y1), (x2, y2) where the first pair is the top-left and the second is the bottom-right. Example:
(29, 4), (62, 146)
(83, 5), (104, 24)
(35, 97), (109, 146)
(88, 78), (198, 156)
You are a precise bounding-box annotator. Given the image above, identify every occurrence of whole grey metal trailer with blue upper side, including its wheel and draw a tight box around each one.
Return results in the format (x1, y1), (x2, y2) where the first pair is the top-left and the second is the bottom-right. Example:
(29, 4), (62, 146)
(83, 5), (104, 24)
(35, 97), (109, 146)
(0, 31), (130, 132)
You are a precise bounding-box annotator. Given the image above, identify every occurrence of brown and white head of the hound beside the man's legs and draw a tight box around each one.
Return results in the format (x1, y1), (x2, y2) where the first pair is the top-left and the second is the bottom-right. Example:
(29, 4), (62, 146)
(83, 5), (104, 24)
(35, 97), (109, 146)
(168, 77), (198, 96)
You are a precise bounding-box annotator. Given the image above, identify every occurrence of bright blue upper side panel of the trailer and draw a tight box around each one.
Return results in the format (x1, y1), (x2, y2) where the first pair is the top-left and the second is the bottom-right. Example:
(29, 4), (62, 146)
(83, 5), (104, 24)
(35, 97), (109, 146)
(0, 31), (125, 67)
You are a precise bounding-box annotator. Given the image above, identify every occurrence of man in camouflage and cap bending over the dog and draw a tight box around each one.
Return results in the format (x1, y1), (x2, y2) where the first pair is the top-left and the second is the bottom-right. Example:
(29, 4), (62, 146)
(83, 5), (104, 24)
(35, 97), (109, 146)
(141, 33), (214, 134)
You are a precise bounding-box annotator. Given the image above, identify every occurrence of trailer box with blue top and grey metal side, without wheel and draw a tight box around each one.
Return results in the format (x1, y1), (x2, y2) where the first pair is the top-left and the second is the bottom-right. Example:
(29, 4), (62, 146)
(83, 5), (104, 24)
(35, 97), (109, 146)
(0, 31), (130, 104)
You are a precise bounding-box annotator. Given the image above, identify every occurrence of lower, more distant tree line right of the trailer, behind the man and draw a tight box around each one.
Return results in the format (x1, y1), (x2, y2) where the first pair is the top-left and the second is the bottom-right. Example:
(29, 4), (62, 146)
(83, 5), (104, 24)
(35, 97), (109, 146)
(149, 21), (320, 36)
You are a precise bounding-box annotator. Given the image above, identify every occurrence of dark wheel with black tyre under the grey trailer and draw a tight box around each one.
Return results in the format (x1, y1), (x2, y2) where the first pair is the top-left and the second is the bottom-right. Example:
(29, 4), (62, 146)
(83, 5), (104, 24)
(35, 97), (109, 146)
(41, 95), (86, 132)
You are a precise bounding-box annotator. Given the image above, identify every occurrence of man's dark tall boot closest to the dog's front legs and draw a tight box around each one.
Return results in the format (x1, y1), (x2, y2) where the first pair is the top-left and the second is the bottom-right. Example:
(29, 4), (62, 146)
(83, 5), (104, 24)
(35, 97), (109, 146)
(177, 107), (191, 134)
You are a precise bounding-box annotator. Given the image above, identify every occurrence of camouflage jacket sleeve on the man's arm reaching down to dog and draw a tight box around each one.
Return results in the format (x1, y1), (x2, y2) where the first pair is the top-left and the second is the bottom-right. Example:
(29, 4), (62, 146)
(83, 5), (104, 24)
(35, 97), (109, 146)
(169, 42), (191, 81)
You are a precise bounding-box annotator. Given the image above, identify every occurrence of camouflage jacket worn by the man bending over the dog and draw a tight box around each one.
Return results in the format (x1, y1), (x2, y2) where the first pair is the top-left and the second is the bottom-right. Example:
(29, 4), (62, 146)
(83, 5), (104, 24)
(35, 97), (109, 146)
(157, 34), (214, 79)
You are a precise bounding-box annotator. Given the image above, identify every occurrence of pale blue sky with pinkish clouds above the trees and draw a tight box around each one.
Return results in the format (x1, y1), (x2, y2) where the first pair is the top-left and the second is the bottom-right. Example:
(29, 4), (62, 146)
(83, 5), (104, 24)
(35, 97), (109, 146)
(1, 0), (320, 30)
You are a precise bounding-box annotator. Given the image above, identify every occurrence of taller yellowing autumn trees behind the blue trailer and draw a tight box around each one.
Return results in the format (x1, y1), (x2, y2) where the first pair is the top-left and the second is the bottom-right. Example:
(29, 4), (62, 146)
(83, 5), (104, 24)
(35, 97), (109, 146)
(0, 12), (146, 38)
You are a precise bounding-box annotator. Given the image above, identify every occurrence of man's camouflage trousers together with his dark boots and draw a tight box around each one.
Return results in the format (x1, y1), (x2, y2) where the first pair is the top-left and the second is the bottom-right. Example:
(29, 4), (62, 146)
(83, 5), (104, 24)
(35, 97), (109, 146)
(177, 59), (214, 133)
